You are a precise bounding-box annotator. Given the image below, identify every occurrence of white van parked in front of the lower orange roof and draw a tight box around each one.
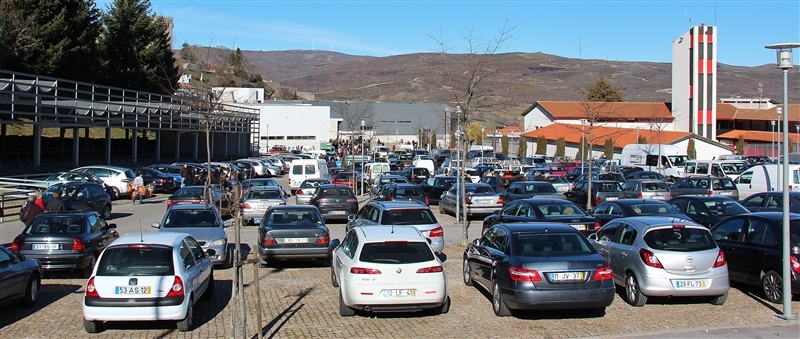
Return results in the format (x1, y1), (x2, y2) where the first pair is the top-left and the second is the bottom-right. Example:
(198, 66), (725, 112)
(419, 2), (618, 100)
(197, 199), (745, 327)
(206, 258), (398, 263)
(619, 144), (690, 182)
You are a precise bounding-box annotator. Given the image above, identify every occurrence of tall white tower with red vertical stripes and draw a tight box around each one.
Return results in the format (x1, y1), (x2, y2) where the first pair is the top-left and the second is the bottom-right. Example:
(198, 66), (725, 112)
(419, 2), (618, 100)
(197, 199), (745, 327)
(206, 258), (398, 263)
(672, 24), (717, 140)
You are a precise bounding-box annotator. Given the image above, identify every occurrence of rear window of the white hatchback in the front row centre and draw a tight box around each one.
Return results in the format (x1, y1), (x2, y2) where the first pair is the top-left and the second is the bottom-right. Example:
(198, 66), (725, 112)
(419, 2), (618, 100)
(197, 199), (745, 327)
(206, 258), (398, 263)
(358, 241), (433, 264)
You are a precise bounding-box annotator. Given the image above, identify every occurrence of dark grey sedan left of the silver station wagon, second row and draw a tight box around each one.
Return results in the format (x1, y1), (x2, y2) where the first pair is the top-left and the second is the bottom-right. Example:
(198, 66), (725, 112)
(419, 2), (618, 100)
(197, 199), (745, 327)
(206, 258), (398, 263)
(258, 206), (332, 267)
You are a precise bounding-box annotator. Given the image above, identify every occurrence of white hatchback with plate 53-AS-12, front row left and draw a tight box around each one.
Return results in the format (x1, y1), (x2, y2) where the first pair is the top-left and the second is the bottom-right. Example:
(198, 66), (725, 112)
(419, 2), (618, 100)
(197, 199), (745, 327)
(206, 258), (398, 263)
(83, 232), (215, 333)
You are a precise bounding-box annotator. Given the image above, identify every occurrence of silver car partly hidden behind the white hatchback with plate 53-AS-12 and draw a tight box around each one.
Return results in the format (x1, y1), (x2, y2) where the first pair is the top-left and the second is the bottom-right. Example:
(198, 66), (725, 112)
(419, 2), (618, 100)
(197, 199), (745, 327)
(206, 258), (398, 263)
(151, 204), (234, 268)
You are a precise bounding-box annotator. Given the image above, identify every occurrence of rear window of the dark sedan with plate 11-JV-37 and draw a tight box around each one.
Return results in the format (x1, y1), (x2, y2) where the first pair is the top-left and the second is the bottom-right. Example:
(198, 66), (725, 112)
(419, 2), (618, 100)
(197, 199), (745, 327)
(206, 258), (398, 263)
(511, 232), (595, 256)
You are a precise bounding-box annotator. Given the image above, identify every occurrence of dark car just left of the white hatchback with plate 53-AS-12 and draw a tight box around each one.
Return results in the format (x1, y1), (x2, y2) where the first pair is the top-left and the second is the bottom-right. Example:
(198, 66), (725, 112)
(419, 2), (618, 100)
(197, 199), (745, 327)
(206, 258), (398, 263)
(11, 212), (119, 278)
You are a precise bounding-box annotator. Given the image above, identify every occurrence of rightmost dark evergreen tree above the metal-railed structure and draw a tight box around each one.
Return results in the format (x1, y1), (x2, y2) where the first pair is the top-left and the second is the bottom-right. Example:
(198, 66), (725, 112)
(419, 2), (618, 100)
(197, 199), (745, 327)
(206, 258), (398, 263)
(100, 0), (178, 94)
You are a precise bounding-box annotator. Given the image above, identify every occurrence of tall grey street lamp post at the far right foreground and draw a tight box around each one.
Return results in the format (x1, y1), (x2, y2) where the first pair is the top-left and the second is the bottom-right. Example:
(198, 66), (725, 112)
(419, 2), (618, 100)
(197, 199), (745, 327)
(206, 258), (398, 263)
(764, 43), (800, 320)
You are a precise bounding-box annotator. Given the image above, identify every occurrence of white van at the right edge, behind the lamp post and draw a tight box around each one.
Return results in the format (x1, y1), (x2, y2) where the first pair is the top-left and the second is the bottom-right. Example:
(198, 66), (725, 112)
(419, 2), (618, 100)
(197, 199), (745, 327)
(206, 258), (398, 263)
(733, 164), (800, 200)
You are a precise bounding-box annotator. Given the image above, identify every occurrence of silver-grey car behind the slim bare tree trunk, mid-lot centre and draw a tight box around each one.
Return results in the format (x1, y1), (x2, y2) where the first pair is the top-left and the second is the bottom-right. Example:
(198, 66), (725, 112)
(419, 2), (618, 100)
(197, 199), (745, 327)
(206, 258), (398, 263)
(439, 183), (503, 216)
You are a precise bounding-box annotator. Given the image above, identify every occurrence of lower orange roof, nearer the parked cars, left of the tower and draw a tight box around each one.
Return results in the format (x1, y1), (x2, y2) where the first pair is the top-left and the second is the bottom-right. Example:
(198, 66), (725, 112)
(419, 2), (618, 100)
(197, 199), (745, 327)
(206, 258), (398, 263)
(522, 123), (692, 148)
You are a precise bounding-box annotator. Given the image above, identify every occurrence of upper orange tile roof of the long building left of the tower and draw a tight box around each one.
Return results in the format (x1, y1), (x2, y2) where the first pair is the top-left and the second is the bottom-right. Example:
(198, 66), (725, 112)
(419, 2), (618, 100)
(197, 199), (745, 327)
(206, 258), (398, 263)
(522, 101), (674, 121)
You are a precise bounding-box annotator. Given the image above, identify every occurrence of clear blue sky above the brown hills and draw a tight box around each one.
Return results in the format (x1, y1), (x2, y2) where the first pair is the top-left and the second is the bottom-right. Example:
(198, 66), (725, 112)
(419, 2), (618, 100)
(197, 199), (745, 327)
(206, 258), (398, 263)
(130, 0), (800, 66)
